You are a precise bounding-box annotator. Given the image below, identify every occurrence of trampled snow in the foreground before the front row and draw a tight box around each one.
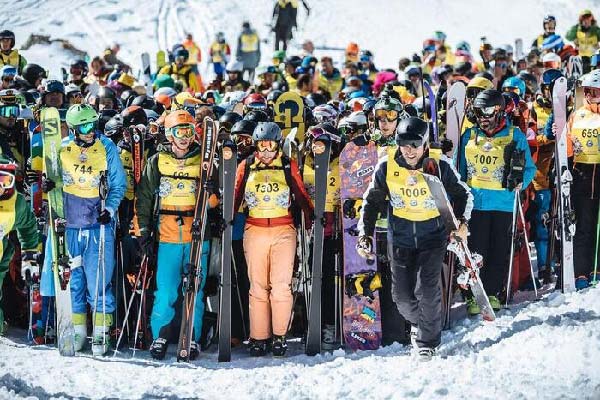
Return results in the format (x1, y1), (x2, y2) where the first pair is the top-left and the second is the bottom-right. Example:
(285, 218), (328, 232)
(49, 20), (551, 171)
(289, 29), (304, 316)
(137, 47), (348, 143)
(0, 289), (600, 400)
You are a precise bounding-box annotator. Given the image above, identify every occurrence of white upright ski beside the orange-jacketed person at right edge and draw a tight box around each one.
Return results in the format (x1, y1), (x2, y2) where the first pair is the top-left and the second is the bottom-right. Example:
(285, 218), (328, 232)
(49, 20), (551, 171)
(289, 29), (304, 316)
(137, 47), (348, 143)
(552, 77), (575, 293)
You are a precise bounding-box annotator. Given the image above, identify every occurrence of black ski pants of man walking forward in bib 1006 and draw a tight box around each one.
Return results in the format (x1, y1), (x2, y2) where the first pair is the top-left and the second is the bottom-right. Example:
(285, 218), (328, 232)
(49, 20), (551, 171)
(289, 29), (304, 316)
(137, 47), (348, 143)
(392, 243), (446, 348)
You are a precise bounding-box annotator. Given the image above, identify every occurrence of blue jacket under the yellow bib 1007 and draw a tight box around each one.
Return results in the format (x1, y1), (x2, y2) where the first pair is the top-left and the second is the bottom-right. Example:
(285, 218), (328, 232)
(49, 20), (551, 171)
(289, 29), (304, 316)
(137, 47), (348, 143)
(459, 125), (537, 212)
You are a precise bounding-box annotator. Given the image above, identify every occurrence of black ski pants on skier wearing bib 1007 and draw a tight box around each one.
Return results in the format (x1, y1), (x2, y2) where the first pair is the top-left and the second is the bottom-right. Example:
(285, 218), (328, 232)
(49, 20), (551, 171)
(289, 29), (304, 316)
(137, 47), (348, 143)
(469, 210), (513, 296)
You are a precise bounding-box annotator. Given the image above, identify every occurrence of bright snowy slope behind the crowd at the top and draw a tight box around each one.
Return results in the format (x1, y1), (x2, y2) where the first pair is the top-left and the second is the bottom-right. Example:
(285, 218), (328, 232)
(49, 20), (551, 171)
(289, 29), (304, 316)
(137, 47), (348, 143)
(0, 0), (600, 73)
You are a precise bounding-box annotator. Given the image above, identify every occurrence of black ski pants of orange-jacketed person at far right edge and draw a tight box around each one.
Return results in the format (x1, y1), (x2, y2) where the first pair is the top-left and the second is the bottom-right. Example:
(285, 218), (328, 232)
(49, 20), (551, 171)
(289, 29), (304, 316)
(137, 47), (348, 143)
(571, 194), (598, 278)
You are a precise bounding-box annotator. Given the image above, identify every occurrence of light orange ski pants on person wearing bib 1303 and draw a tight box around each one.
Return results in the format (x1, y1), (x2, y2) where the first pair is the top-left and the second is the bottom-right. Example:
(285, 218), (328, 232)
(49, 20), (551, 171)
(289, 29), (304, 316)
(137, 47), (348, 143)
(244, 224), (296, 340)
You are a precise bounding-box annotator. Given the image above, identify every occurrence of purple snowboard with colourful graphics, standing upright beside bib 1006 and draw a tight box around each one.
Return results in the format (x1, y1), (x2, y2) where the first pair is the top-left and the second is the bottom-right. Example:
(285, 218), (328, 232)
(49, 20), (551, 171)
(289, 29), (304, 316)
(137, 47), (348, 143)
(339, 142), (382, 350)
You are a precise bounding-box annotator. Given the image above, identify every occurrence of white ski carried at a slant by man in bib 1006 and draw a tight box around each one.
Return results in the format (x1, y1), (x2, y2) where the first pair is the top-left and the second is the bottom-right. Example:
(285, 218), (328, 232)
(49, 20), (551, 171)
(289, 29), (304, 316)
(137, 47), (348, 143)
(423, 159), (496, 321)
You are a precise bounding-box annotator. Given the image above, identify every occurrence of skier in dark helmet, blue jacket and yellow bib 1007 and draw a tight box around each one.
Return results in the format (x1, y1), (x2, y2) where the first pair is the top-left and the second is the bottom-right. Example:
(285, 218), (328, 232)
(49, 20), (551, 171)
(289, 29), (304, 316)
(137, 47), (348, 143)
(459, 89), (536, 315)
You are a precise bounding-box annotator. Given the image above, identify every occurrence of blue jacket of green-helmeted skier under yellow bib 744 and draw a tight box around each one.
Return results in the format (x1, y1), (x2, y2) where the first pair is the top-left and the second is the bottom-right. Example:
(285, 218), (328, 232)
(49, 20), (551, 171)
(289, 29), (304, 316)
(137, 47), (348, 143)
(61, 135), (127, 228)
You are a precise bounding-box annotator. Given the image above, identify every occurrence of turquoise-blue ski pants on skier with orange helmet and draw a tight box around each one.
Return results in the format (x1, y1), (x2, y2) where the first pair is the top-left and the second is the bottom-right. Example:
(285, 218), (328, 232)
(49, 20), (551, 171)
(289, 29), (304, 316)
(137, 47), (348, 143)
(150, 240), (210, 342)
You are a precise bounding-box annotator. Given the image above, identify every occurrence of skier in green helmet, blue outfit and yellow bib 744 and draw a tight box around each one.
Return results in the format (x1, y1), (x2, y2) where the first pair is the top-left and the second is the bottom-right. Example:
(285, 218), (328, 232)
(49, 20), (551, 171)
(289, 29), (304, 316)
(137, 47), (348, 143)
(42, 104), (127, 355)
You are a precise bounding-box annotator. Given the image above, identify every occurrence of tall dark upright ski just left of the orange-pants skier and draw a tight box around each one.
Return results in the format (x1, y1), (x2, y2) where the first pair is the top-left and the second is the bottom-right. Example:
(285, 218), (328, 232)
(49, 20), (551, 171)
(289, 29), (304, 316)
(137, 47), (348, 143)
(219, 140), (237, 362)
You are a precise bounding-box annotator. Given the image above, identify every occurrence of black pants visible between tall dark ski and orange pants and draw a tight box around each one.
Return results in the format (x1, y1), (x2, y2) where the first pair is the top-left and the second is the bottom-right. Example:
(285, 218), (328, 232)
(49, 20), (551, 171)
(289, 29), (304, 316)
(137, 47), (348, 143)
(231, 240), (250, 340)
